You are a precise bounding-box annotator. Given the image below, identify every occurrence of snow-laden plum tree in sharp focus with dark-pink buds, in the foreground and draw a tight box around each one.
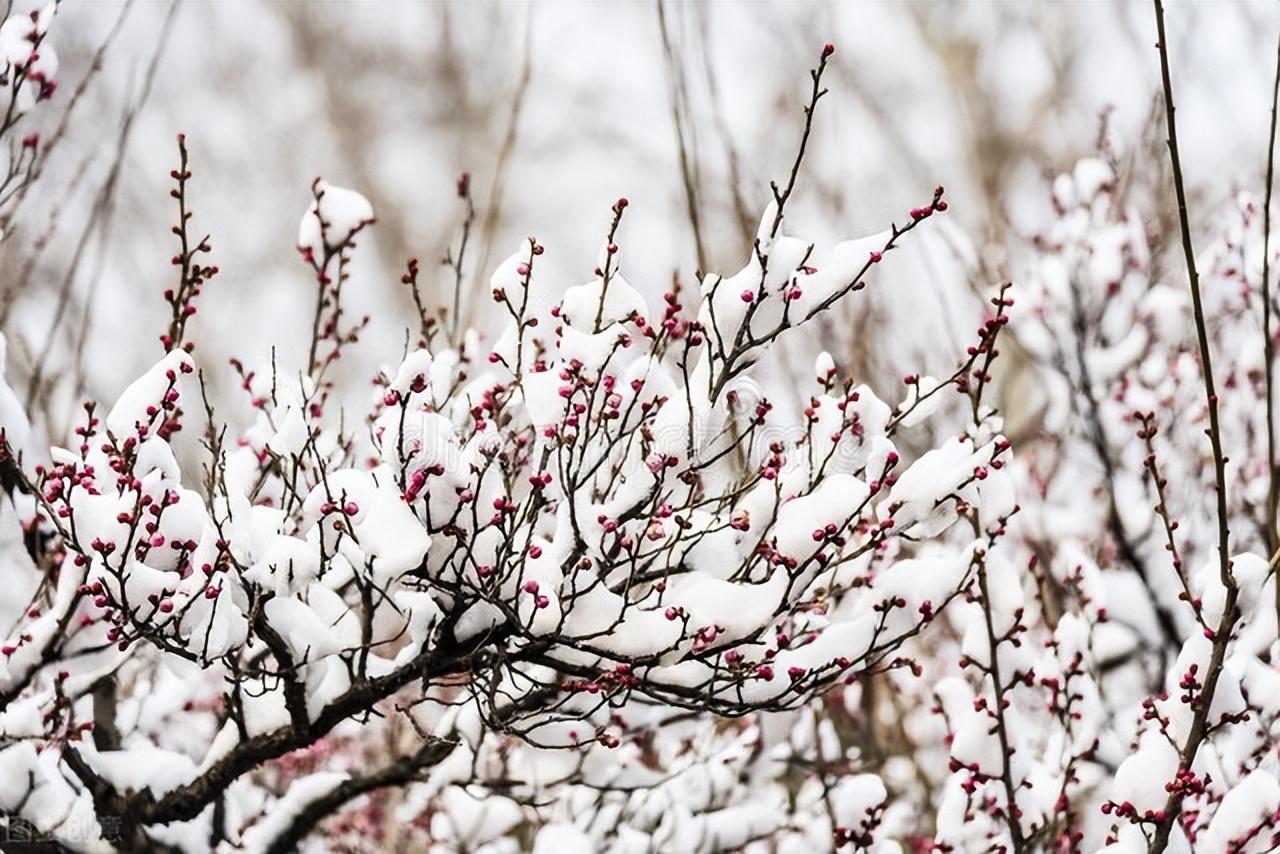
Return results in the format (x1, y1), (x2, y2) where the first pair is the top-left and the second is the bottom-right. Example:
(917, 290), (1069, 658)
(0, 46), (1015, 850)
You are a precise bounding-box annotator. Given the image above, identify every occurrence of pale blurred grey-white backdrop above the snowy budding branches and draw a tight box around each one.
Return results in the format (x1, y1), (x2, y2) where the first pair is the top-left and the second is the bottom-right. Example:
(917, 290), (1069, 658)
(0, 0), (1280, 438)
